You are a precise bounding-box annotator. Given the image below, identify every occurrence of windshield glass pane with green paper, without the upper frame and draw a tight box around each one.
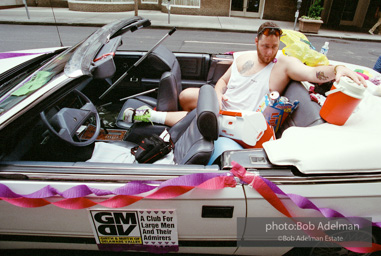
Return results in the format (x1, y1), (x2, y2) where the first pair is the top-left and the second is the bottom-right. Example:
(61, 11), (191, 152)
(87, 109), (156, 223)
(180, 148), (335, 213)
(0, 47), (76, 115)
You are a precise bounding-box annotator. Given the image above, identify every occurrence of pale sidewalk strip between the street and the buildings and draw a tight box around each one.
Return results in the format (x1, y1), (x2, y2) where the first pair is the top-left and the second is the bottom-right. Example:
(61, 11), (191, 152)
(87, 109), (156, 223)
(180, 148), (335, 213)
(0, 7), (381, 42)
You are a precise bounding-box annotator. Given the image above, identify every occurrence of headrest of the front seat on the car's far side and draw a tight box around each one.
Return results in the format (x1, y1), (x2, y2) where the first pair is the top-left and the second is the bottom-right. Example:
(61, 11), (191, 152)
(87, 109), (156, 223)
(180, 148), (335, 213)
(147, 45), (177, 72)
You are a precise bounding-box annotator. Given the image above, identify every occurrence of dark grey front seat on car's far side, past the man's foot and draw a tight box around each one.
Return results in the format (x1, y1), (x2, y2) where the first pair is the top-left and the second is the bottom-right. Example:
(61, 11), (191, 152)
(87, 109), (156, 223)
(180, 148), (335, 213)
(116, 45), (182, 129)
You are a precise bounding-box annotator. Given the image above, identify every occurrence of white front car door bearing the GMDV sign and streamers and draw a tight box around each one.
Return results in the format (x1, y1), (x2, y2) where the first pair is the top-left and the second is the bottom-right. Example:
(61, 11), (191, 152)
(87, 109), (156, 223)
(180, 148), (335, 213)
(0, 162), (246, 254)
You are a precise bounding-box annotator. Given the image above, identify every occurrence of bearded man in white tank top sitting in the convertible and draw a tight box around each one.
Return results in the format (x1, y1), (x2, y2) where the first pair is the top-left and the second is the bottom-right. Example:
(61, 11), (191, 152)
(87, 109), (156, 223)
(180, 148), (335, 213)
(124, 22), (366, 126)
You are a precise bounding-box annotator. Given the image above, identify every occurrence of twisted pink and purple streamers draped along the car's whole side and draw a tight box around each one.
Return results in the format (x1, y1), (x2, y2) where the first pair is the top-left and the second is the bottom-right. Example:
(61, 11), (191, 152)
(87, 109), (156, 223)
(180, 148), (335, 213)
(0, 166), (381, 253)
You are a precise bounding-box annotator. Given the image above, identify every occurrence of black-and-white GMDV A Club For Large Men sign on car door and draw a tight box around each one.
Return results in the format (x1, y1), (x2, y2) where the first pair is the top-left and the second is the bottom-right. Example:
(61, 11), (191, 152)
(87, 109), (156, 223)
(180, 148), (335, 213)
(89, 209), (178, 251)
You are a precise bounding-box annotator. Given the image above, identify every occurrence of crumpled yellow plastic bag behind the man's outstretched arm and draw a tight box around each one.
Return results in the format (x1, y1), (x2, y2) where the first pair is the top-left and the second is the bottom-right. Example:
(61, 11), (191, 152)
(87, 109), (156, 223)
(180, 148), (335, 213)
(280, 29), (329, 67)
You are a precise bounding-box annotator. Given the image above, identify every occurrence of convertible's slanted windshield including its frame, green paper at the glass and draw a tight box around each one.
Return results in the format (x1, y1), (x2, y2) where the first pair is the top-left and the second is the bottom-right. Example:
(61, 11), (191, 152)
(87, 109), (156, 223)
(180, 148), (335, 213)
(0, 17), (150, 116)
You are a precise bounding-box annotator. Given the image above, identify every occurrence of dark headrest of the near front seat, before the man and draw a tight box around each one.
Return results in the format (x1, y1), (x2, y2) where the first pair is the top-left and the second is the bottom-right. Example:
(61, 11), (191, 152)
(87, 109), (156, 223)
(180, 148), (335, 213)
(197, 84), (220, 140)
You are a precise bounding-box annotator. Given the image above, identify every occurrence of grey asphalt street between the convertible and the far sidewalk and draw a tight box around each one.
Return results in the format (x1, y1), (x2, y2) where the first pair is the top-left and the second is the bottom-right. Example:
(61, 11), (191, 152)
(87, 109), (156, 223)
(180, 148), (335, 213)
(0, 24), (381, 68)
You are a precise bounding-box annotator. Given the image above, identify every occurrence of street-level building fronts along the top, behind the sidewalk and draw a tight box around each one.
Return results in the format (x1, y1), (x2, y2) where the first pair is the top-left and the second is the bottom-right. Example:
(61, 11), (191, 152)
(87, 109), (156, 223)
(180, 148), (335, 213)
(4, 0), (380, 31)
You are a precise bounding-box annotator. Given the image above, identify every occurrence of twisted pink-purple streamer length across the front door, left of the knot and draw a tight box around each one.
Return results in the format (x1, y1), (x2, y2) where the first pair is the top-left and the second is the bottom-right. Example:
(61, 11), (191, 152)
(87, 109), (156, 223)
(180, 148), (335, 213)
(0, 173), (236, 210)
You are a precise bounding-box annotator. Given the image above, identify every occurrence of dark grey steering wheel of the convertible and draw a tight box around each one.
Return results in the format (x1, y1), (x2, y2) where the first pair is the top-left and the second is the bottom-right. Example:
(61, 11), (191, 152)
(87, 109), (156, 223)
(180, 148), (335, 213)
(40, 90), (101, 147)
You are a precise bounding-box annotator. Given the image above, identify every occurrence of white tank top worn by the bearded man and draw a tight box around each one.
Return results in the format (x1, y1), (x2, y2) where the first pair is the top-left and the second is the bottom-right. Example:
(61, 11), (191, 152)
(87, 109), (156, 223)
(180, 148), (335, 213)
(222, 51), (279, 111)
